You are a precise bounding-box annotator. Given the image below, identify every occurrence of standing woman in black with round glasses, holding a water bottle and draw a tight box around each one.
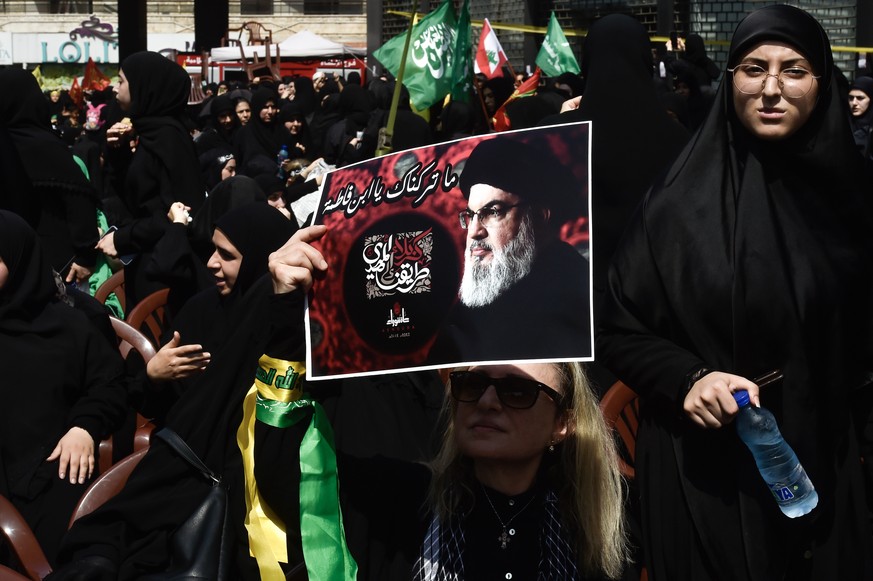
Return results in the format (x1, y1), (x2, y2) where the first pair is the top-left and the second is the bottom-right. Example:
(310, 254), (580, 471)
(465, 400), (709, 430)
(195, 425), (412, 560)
(597, 5), (873, 581)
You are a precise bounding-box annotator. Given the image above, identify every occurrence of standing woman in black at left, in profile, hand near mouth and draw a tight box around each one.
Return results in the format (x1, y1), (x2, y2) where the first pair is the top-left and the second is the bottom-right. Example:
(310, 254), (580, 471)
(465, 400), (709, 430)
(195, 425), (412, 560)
(98, 51), (205, 305)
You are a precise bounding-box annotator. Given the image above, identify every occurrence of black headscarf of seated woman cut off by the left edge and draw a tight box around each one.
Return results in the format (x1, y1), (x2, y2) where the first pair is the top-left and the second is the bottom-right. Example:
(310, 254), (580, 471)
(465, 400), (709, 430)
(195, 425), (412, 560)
(0, 210), (57, 332)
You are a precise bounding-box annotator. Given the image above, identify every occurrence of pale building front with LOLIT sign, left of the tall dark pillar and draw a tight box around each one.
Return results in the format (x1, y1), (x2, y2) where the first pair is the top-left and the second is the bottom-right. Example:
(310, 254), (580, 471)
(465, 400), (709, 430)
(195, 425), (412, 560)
(0, 0), (367, 88)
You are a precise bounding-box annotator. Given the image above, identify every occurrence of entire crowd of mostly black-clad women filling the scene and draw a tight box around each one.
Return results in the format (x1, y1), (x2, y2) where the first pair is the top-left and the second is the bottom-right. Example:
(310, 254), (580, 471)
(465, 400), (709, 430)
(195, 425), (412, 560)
(0, 5), (873, 581)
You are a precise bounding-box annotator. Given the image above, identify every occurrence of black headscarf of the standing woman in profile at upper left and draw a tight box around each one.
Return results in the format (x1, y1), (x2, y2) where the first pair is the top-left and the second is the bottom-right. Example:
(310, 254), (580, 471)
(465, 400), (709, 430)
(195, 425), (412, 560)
(120, 51), (205, 213)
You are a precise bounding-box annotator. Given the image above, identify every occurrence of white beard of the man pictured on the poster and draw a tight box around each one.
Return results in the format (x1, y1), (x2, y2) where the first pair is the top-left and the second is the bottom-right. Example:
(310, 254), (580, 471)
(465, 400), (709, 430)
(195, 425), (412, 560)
(458, 215), (536, 307)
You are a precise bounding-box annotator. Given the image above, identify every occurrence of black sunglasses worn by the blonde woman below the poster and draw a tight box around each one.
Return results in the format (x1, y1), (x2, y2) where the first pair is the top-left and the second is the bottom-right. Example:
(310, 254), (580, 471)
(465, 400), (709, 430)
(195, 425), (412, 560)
(449, 371), (564, 410)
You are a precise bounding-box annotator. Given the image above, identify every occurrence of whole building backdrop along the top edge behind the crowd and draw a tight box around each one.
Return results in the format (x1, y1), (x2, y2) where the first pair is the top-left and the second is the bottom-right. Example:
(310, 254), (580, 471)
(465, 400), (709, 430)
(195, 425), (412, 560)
(0, 0), (873, 84)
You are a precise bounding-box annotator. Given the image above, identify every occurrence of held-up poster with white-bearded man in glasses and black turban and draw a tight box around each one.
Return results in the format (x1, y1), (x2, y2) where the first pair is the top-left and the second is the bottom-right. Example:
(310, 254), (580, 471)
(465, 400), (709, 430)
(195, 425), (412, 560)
(306, 122), (594, 379)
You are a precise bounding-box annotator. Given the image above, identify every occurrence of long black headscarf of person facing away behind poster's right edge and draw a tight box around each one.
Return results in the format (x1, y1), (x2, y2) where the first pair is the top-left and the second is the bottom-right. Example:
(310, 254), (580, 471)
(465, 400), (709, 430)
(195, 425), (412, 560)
(542, 14), (688, 296)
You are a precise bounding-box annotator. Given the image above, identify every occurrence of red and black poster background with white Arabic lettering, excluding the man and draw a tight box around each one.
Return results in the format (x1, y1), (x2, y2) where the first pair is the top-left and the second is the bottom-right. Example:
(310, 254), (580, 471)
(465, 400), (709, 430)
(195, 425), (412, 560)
(307, 123), (590, 379)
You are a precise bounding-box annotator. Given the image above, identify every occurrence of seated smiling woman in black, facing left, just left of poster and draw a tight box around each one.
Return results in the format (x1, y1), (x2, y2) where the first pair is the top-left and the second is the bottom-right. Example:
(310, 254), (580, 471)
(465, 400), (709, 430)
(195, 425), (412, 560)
(49, 203), (303, 581)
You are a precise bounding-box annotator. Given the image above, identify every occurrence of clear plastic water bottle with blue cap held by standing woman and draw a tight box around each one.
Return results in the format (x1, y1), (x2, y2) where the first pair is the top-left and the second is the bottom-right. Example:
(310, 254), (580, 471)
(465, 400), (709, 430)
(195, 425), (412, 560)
(734, 390), (818, 518)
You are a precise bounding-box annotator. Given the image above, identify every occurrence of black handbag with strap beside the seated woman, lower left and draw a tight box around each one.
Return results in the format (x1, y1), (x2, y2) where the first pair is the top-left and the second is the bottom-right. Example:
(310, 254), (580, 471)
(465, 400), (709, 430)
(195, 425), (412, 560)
(140, 428), (233, 581)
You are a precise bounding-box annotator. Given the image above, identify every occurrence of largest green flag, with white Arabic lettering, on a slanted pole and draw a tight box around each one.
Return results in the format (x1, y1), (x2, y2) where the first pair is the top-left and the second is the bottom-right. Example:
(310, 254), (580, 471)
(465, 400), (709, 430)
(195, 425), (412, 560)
(373, 0), (457, 110)
